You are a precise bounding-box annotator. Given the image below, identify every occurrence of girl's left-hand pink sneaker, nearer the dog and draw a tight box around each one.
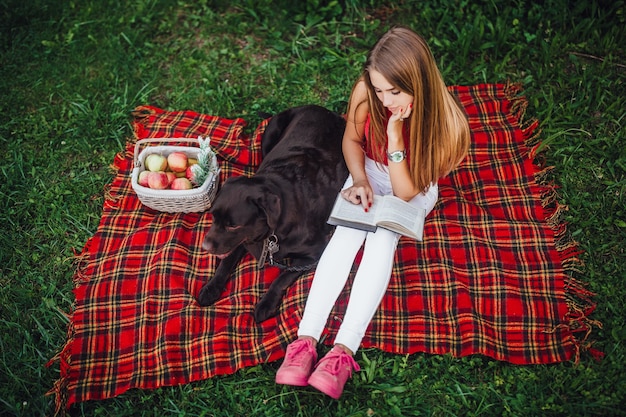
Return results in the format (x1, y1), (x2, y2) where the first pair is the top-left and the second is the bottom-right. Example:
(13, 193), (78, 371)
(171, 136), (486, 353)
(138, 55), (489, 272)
(276, 339), (317, 387)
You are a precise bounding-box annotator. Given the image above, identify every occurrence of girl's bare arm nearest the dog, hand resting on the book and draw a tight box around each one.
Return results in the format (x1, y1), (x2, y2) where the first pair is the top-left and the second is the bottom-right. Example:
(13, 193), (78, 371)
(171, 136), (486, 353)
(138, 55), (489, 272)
(342, 80), (374, 210)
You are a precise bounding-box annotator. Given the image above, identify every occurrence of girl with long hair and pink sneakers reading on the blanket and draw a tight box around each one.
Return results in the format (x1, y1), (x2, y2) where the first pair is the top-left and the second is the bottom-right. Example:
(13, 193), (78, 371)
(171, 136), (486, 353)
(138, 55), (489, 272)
(276, 28), (470, 399)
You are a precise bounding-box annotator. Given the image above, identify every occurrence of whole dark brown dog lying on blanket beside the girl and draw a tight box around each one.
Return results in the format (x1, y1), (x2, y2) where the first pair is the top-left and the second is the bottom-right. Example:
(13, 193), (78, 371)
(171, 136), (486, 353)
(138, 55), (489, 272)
(197, 105), (348, 322)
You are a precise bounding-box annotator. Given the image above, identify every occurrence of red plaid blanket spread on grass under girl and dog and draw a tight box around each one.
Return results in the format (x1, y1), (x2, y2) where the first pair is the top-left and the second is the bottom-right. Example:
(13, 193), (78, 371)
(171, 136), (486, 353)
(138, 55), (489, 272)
(51, 84), (598, 410)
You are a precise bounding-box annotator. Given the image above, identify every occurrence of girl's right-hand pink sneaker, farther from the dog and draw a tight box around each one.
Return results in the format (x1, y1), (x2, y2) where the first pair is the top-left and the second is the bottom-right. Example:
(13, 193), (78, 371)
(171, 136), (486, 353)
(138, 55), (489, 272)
(309, 346), (361, 400)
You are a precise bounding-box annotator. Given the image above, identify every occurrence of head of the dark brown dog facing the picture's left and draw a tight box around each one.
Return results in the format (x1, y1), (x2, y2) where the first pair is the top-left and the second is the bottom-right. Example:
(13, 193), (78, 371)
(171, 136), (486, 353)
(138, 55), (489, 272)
(202, 177), (281, 258)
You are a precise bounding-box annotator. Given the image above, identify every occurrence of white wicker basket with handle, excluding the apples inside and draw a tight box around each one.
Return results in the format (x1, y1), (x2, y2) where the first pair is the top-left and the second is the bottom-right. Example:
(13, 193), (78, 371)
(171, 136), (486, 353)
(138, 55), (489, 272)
(132, 138), (219, 213)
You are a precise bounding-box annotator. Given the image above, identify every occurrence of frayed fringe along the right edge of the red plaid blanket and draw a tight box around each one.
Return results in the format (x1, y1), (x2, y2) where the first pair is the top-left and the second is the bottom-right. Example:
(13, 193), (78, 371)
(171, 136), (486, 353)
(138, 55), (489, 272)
(504, 83), (604, 364)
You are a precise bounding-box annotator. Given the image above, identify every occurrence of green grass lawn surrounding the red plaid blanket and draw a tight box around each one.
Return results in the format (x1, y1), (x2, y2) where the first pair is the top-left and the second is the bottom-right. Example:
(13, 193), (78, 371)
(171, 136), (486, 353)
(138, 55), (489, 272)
(0, 0), (626, 416)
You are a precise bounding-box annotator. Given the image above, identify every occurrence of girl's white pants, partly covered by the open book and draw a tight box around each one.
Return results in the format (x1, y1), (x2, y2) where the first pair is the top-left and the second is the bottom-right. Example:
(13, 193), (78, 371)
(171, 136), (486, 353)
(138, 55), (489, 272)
(298, 158), (438, 352)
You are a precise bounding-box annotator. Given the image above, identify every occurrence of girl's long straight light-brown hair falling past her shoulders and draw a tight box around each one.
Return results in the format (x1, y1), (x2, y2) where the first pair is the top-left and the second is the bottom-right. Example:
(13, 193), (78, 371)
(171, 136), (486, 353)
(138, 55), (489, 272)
(348, 27), (470, 190)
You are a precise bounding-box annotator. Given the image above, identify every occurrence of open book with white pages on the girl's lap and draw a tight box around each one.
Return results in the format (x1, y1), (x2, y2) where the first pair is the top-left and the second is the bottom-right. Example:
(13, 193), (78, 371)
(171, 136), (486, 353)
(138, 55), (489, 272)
(328, 194), (426, 240)
